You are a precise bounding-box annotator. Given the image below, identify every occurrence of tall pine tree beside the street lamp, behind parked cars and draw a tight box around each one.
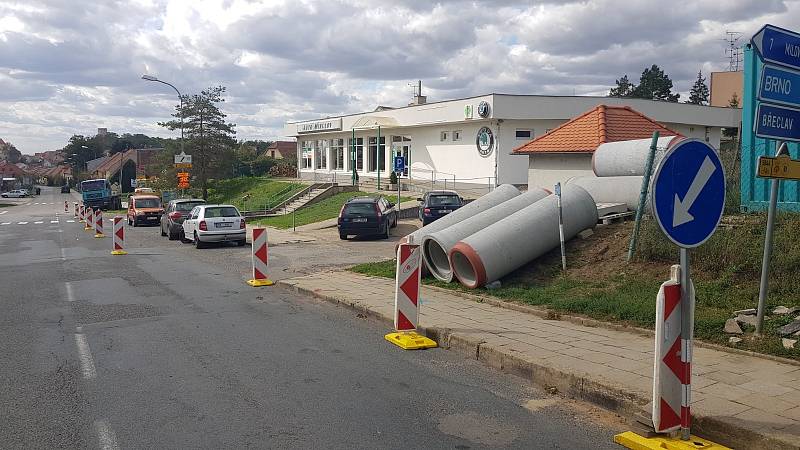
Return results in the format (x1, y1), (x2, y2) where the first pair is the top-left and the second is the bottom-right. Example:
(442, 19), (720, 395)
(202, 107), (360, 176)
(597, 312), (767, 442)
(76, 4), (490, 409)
(159, 86), (236, 200)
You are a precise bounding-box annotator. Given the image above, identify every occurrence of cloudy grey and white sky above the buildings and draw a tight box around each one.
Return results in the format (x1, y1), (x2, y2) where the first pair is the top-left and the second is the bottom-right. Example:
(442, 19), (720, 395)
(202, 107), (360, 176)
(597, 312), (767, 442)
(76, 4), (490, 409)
(0, 0), (800, 154)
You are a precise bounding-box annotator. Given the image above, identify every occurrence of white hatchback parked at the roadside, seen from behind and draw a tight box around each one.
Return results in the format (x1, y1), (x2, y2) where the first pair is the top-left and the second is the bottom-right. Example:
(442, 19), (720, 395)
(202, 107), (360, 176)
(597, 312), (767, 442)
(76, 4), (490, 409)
(183, 205), (247, 248)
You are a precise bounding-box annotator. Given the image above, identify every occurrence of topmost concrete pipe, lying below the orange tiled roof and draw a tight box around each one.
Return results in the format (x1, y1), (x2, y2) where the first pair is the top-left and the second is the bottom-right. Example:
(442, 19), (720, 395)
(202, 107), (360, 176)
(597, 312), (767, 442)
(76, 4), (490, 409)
(592, 136), (683, 177)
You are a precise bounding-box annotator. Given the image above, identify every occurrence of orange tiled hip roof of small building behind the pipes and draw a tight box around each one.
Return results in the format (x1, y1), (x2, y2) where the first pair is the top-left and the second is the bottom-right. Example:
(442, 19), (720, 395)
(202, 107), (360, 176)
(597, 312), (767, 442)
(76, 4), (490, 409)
(514, 105), (680, 154)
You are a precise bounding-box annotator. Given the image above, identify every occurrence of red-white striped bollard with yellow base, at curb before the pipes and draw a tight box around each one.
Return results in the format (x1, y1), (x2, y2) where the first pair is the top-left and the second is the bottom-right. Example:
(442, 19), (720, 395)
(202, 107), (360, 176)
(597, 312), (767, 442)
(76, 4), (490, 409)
(385, 237), (436, 350)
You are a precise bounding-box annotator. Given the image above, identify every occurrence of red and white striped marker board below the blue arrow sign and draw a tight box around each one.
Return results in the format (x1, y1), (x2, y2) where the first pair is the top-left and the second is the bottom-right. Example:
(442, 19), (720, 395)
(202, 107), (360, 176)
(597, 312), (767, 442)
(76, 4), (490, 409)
(653, 266), (694, 433)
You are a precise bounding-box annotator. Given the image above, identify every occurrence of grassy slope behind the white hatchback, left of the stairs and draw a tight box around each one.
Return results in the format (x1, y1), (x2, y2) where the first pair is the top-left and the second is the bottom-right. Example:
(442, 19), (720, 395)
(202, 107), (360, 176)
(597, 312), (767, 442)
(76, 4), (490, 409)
(208, 177), (306, 210)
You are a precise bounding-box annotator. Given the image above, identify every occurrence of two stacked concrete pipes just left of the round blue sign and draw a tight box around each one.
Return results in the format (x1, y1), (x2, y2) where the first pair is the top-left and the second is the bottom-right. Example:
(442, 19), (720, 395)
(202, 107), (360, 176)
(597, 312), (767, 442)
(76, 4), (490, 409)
(567, 136), (683, 211)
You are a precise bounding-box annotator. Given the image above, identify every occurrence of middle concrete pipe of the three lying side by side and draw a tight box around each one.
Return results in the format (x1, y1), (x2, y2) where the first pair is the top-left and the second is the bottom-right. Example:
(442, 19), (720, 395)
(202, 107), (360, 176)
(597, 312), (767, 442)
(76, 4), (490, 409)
(422, 188), (550, 283)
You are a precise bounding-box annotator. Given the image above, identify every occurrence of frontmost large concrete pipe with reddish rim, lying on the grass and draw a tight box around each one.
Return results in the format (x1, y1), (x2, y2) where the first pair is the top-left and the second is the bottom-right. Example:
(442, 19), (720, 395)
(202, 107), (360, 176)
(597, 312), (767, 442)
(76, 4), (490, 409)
(450, 184), (597, 289)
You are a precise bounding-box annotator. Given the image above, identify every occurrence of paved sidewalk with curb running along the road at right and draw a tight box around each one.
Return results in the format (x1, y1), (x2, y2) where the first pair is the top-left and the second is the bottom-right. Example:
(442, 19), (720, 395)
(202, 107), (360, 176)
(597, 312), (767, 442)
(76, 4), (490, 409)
(280, 272), (800, 449)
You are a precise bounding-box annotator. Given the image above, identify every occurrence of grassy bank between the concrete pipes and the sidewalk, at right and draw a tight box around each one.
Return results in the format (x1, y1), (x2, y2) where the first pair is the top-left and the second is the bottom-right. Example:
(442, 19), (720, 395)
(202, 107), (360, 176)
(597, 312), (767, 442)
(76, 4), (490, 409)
(351, 214), (800, 359)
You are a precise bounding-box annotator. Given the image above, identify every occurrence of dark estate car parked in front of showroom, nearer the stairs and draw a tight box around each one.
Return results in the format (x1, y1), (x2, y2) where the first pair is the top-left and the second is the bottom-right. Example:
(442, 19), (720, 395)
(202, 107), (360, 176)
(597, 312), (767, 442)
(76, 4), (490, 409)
(337, 197), (397, 239)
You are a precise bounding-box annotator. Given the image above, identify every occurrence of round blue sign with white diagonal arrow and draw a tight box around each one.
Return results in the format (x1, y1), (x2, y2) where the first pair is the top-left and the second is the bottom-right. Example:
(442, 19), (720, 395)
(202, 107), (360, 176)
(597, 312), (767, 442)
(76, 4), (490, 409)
(650, 139), (725, 248)
